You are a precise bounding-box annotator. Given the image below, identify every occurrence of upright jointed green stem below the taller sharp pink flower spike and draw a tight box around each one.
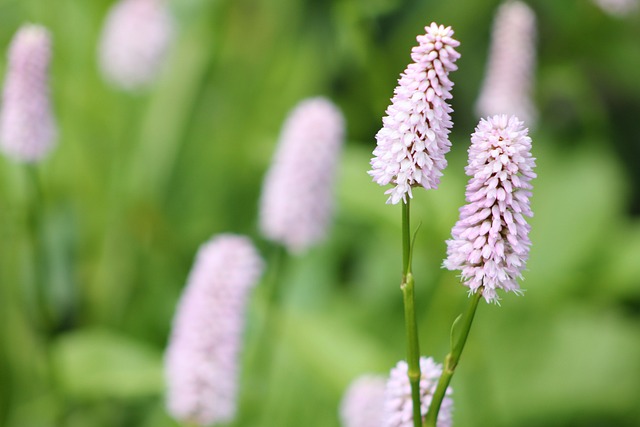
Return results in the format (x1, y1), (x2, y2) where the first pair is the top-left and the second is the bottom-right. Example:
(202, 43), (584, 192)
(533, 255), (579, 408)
(400, 199), (422, 427)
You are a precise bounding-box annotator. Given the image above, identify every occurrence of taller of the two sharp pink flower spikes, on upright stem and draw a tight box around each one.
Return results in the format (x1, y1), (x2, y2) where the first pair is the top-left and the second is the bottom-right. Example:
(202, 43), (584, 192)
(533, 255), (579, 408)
(369, 23), (460, 204)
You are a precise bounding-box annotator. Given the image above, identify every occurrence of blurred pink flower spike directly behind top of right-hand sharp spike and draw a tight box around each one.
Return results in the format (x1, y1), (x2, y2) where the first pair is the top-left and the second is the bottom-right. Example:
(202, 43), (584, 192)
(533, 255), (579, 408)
(476, 1), (537, 124)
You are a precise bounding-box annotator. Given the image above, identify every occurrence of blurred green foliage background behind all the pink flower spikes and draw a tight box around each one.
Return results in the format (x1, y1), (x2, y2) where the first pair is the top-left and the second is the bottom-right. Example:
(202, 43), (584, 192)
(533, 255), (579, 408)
(0, 0), (640, 427)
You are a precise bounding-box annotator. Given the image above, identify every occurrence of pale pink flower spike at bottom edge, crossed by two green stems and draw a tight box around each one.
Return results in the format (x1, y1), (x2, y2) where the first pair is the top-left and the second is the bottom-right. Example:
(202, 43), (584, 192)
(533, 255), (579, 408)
(383, 357), (453, 427)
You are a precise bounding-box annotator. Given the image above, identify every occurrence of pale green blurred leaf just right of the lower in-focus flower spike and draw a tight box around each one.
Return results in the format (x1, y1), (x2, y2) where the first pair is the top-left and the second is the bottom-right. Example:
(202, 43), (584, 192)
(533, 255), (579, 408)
(523, 141), (626, 303)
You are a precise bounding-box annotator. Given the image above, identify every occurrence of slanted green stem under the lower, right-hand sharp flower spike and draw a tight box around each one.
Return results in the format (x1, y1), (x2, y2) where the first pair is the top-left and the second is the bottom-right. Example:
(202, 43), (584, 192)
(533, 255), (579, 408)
(425, 288), (482, 427)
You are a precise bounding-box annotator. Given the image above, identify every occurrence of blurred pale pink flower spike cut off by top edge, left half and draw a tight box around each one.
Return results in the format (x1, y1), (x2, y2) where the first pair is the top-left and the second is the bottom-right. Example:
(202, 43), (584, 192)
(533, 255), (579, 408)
(98, 0), (174, 90)
